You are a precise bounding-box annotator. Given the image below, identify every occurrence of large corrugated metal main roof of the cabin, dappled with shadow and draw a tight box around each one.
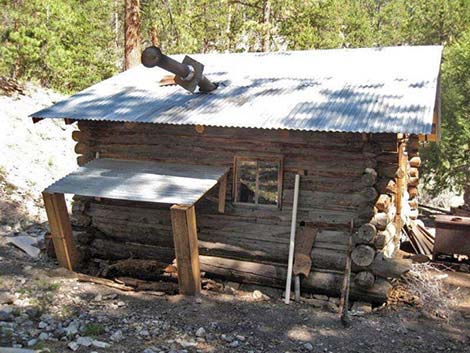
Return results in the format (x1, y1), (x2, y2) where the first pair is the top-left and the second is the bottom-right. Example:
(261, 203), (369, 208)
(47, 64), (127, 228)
(31, 46), (442, 134)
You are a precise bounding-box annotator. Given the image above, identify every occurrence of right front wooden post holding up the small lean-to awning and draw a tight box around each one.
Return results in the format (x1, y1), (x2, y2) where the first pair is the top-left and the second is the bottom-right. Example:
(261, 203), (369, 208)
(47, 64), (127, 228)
(171, 205), (201, 295)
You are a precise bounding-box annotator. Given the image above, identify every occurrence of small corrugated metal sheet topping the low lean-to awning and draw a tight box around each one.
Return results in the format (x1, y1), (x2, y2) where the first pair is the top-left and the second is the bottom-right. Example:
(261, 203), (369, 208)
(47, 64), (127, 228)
(44, 158), (228, 205)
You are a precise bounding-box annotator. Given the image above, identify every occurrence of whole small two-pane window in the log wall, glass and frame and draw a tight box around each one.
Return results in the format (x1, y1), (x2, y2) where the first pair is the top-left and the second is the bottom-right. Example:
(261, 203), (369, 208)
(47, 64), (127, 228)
(234, 157), (282, 207)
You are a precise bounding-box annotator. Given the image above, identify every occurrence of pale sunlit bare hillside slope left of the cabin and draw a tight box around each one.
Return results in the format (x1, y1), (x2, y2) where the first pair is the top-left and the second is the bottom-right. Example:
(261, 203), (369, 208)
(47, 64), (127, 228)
(0, 84), (76, 233)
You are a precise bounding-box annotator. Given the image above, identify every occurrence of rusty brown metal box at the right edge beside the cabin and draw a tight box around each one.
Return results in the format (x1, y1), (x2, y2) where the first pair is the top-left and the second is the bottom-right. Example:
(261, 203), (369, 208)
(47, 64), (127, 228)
(433, 215), (470, 257)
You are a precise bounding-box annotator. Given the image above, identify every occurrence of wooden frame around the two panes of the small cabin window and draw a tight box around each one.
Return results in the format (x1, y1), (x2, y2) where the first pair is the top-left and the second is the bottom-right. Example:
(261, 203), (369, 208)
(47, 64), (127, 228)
(232, 155), (284, 209)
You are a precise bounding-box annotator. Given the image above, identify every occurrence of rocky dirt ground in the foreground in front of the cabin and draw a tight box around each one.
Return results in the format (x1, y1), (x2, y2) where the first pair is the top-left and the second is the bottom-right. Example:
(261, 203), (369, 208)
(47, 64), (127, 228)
(0, 231), (470, 353)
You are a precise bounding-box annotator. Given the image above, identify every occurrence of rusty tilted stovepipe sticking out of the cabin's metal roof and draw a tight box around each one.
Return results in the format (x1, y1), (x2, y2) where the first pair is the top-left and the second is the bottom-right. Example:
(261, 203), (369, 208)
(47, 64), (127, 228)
(141, 46), (217, 93)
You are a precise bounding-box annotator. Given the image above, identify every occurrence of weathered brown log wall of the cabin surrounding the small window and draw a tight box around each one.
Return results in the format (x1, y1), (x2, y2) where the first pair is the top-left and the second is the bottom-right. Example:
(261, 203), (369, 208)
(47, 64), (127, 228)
(73, 121), (408, 300)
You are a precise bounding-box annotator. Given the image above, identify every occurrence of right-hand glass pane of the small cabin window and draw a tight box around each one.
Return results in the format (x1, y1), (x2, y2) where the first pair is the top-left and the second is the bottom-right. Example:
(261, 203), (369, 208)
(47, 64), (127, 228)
(258, 161), (279, 205)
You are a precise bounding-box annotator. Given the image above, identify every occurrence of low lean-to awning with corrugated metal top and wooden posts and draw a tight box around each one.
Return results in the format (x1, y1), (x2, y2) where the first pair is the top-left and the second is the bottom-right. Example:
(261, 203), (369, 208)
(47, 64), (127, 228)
(43, 158), (228, 295)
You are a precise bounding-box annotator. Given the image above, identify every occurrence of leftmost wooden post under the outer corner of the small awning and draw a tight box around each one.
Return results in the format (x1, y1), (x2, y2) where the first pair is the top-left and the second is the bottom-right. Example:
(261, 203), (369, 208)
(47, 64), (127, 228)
(42, 192), (78, 271)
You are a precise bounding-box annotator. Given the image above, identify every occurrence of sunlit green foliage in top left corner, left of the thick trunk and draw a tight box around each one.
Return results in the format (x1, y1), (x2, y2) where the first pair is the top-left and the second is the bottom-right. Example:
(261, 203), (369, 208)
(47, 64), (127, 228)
(0, 0), (116, 92)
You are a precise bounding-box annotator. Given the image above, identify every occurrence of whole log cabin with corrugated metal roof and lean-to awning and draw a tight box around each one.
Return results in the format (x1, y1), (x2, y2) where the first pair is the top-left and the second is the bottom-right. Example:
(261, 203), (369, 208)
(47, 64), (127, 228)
(31, 46), (442, 303)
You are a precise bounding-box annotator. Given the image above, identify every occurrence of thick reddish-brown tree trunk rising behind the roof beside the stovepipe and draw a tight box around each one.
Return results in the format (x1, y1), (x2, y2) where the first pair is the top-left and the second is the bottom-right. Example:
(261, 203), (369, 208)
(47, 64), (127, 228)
(124, 0), (140, 70)
